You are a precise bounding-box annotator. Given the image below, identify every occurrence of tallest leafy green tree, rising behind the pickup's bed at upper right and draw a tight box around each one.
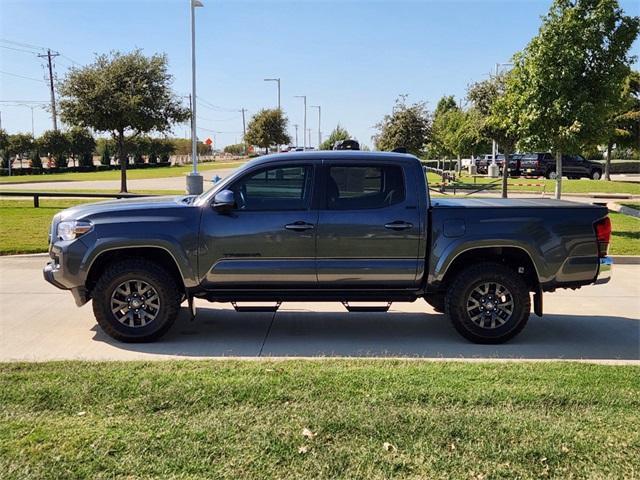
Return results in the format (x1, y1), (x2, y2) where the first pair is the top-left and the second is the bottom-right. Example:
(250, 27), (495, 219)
(507, 0), (640, 198)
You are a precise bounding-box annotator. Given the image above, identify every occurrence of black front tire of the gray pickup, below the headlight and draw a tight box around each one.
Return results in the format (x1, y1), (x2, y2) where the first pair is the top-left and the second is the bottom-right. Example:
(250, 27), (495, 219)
(93, 258), (182, 343)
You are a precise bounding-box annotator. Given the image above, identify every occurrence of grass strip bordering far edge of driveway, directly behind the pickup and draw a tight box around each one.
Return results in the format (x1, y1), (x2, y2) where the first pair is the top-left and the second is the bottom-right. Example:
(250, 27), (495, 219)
(0, 197), (640, 255)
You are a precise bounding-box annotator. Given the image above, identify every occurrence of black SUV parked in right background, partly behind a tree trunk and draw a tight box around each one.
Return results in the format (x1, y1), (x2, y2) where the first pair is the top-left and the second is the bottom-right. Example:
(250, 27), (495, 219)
(509, 152), (602, 180)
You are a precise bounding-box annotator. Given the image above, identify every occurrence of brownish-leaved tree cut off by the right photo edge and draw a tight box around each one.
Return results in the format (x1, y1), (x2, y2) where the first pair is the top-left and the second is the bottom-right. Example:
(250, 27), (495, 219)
(604, 71), (640, 181)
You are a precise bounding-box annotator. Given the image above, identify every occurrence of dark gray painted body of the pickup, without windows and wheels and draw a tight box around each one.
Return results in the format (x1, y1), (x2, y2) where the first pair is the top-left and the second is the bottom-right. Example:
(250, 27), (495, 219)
(49, 151), (607, 299)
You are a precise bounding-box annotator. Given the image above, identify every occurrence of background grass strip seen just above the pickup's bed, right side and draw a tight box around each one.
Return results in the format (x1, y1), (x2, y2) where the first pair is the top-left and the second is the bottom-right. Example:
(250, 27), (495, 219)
(427, 173), (640, 195)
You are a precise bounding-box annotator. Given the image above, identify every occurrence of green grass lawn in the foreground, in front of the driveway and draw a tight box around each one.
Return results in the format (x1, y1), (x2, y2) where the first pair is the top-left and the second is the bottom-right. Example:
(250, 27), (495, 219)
(0, 360), (640, 480)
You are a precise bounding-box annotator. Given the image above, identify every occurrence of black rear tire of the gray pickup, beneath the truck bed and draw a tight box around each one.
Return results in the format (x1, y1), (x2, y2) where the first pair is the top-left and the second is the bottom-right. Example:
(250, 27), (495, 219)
(445, 262), (531, 344)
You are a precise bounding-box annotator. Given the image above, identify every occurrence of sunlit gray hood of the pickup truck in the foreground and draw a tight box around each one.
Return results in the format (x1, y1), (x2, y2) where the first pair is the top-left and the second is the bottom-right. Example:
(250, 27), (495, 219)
(58, 195), (196, 220)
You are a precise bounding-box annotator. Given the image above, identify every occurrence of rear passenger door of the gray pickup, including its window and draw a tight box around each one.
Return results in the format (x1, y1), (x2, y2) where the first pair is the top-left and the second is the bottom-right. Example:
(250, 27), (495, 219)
(316, 160), (421, 288)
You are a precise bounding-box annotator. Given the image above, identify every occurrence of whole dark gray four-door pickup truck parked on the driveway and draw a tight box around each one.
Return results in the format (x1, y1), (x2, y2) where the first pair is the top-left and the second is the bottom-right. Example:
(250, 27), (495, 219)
(44, 151), (612, 343)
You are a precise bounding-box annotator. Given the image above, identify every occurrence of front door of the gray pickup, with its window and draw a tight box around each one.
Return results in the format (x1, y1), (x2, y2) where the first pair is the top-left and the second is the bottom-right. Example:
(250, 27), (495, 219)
(199, 163), (318, 289)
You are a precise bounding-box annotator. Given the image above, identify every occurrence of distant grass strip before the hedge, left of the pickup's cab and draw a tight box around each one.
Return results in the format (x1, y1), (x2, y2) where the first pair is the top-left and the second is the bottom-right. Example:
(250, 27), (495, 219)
(0, 161), (245, 185)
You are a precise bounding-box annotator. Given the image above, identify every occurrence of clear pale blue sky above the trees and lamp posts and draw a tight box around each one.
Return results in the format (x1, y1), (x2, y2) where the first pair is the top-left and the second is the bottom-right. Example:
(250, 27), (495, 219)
(0, 0), (640, 147)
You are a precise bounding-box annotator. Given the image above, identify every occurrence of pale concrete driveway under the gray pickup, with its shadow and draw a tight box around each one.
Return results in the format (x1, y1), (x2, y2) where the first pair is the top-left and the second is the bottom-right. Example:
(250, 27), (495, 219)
(0, 256), (640, 363)
